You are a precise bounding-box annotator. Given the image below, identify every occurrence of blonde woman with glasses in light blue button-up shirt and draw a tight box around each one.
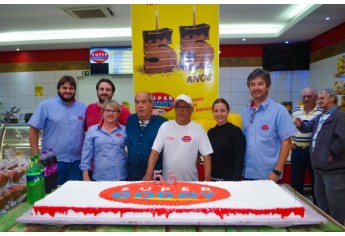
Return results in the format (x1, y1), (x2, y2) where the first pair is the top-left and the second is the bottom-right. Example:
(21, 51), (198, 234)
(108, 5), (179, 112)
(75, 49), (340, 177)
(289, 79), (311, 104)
(80, 100), (127, 181)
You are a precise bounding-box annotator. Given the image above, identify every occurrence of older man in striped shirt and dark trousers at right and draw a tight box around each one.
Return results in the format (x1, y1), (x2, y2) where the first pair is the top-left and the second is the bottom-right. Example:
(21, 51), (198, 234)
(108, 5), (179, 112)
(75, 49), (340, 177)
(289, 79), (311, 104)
(291, 87), (322, 204)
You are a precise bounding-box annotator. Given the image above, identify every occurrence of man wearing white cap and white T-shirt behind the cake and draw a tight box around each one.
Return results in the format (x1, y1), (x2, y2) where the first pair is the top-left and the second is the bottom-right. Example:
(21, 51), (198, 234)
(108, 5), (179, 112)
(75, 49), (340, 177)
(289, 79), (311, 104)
(143, 94), (213, 181)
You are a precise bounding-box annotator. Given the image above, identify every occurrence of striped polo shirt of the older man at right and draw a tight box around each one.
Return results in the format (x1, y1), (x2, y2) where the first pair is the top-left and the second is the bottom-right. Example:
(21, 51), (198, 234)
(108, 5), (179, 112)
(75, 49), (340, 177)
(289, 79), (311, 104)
(291, 105), (322, 147)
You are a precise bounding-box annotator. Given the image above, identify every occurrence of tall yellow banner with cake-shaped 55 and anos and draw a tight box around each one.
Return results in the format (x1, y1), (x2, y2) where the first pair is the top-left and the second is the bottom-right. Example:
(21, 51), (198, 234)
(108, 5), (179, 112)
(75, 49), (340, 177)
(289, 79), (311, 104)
(132, 4), (219, 119)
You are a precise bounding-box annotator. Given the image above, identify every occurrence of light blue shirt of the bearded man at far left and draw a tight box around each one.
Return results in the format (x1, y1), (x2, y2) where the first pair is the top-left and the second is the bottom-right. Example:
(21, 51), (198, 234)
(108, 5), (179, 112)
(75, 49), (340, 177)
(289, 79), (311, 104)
(28, 95), (86, 162)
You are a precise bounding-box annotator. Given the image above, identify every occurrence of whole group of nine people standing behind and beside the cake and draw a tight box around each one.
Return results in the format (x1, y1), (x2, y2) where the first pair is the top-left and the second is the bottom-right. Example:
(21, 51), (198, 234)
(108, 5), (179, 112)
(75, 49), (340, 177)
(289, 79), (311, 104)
(28, 69), (345, 224)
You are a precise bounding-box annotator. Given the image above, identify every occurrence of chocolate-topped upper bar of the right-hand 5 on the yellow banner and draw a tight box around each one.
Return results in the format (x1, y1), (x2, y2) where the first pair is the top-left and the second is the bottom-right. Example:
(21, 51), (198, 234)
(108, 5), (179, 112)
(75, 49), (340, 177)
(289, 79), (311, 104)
(180, 23), (210, 40)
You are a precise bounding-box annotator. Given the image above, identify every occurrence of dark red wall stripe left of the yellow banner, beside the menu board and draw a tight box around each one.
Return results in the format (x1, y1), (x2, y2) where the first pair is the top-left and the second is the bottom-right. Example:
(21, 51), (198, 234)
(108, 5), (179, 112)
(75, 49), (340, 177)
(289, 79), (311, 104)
(0, 49), (89, 63)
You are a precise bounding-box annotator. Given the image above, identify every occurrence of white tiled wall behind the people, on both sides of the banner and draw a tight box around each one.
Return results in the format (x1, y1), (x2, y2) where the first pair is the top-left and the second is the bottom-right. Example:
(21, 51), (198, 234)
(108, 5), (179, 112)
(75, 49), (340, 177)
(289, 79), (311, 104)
(0, 55), (341, 121)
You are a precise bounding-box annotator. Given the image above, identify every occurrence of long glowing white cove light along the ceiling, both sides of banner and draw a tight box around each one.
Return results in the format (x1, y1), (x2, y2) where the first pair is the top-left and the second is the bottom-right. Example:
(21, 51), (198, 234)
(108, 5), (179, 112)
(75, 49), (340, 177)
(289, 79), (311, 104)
(0, 4), (321, 45)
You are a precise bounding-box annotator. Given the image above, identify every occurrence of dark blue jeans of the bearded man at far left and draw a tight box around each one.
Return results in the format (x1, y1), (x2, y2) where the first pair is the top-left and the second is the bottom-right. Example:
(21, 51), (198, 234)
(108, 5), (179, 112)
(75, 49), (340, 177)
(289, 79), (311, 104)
(58, 161), (83, 185)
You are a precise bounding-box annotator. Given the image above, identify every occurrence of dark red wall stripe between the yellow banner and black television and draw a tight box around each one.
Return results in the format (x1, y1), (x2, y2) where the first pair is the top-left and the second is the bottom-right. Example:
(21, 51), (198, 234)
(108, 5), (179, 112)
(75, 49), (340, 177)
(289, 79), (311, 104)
(219, 44), (263, 57)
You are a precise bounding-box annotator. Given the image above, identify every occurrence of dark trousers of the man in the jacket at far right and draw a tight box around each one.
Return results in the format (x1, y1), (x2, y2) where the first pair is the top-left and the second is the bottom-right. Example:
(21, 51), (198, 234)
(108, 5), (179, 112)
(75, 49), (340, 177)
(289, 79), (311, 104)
(314, 170), (345, 225)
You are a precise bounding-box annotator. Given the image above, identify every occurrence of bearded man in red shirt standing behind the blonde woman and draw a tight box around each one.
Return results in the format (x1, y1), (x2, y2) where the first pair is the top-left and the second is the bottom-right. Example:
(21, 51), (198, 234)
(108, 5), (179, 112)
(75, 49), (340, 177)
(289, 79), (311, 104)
(85, 78), (131, 131)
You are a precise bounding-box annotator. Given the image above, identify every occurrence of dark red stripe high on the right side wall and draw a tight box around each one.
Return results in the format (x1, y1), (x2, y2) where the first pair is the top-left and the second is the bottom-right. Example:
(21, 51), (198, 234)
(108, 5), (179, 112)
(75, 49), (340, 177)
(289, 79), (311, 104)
(310, 22), (345, 52)
